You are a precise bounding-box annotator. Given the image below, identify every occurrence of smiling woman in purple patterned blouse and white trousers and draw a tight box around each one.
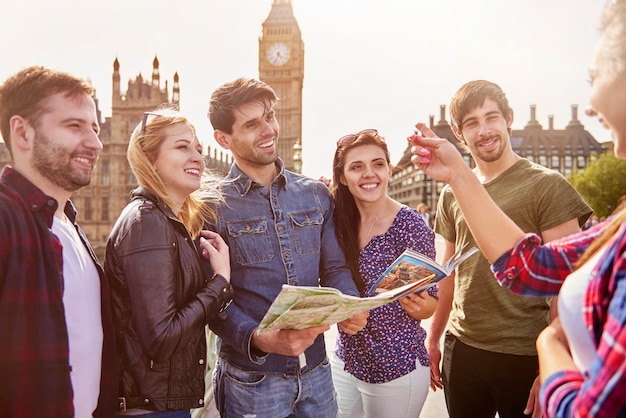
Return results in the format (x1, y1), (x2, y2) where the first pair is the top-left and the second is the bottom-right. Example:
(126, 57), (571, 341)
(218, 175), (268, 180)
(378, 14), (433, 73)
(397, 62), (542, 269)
(331, 129), (437, 418)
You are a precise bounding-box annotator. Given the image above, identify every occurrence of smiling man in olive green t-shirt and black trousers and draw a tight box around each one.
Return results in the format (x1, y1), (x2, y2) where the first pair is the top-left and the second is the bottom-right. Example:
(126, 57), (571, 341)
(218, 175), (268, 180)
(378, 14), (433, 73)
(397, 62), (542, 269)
(420, 80), (592, 418)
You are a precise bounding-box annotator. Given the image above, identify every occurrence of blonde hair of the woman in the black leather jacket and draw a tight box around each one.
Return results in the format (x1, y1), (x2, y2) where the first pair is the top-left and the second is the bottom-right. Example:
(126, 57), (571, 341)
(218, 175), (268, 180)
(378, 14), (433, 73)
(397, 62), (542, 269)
(126, 108), (221, 239)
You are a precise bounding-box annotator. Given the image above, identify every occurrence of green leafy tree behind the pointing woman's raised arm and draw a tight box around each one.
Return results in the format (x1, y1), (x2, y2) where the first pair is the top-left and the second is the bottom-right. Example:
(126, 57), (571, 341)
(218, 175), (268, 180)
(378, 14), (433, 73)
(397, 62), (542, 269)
(569, 152), (626, 218)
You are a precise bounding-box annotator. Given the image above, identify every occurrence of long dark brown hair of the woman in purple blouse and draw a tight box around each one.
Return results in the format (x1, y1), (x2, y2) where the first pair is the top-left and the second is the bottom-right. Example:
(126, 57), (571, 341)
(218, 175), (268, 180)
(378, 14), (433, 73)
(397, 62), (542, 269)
(333, 133), (391, 292)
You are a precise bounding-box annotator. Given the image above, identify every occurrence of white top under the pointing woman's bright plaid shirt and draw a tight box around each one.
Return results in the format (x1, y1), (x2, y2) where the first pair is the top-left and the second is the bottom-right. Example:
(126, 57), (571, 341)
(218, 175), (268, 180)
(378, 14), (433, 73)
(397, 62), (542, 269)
(558, 249), (605, 373)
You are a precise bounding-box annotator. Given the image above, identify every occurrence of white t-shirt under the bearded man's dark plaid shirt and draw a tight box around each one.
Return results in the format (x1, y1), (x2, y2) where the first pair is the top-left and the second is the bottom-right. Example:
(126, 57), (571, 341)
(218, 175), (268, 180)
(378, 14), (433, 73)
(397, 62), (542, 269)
(52, 216), (103, 418)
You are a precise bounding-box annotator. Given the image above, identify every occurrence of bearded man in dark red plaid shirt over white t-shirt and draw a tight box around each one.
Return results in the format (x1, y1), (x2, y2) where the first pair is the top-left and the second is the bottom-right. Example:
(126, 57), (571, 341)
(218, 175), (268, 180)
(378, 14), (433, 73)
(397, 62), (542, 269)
(0, 66), (117, 418)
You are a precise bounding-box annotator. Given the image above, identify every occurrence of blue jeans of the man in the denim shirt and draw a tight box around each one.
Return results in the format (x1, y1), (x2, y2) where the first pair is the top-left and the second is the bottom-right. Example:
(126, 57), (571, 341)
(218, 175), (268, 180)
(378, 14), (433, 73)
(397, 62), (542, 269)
(213, 359), (337, 418)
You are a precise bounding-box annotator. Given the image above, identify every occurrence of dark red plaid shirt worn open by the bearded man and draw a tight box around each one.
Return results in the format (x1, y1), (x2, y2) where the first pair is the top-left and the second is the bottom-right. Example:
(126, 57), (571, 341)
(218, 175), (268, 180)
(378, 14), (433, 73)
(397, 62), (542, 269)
(0, 166), (117, 418)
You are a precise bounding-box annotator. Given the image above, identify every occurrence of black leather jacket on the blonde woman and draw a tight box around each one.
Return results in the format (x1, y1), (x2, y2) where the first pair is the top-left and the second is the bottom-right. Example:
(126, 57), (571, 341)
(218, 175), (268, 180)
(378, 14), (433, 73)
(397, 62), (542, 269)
(104, 188), (232, 411)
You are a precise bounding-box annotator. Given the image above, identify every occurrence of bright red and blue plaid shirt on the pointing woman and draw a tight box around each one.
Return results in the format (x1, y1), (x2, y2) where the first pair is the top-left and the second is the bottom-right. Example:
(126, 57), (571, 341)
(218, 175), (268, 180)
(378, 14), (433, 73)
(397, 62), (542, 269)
(492, 221), (626, 418)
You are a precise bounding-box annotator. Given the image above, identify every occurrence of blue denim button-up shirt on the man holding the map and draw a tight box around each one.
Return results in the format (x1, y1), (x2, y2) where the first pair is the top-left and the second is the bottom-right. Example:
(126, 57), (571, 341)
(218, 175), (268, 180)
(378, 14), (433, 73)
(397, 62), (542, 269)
(210, 160), (359, 374)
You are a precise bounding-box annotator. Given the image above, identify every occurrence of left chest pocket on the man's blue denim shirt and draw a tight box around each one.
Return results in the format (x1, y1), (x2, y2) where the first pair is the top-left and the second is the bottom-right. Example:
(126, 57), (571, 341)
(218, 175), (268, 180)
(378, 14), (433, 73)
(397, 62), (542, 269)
(226, 218), (274, 265)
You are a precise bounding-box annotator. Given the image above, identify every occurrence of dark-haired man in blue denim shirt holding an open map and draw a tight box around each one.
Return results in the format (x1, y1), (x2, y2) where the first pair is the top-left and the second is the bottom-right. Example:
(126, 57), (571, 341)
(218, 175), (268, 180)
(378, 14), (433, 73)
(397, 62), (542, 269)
(209, 78), (368, 417)
